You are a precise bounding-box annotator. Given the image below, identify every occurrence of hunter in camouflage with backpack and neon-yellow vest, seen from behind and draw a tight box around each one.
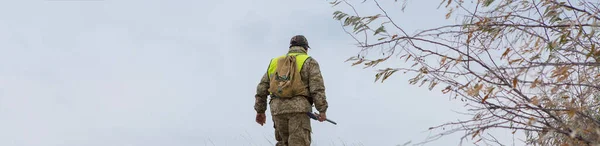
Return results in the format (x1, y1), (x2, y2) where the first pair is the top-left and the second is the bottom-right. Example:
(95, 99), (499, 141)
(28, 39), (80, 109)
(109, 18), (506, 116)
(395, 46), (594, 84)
(254, 35), (328, 146)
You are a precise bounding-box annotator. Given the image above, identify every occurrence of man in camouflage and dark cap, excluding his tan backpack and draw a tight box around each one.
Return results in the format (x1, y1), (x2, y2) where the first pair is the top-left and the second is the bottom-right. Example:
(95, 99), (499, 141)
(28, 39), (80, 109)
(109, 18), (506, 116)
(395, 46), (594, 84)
(254, 35), (328, 146)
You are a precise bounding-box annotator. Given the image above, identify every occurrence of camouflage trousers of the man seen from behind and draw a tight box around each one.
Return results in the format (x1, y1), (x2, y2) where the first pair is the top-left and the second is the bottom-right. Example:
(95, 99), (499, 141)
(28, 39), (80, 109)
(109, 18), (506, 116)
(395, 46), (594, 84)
(273, 113), (312, 146)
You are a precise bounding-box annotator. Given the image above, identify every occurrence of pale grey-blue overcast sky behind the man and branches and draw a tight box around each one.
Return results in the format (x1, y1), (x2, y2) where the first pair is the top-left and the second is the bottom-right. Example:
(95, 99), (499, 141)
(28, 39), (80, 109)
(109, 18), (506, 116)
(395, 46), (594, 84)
(0, 0), (524, 146)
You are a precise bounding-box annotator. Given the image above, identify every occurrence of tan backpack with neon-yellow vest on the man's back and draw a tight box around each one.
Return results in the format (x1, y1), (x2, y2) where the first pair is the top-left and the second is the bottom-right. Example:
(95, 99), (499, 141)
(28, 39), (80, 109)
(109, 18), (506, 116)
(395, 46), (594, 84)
(268, 53), (312, 100)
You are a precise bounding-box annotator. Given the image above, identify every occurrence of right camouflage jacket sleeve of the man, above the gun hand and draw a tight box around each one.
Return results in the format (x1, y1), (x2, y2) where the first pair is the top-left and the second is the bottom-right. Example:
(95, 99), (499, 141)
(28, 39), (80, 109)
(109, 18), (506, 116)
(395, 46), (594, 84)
(307, 58), (329, 112)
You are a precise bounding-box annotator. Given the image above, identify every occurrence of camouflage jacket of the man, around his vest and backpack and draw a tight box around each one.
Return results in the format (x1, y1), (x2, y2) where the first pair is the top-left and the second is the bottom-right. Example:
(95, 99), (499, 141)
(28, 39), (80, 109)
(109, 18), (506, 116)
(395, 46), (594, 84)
(254, 47), (328, 115)
